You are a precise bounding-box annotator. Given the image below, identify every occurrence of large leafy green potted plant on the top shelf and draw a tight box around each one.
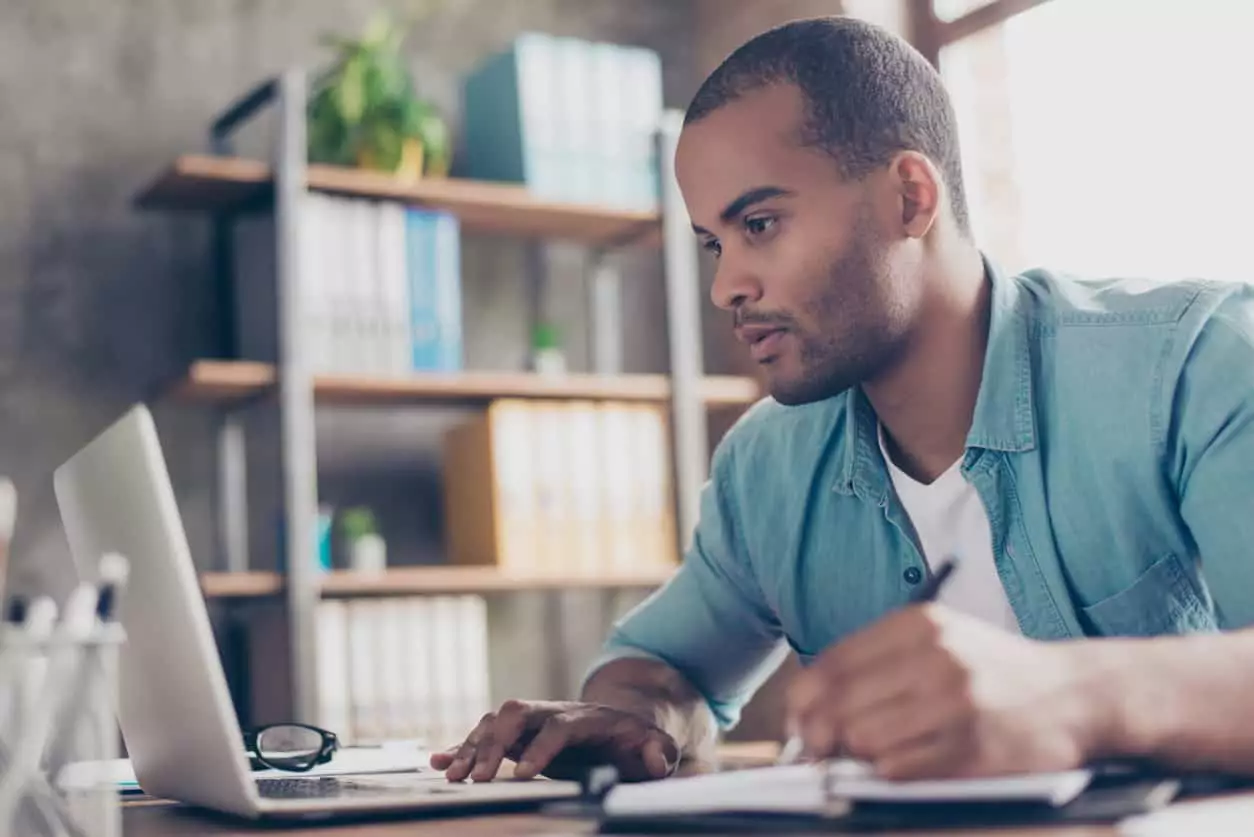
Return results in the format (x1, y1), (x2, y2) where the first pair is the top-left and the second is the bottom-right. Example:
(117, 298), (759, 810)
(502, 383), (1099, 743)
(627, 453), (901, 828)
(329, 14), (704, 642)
(308, 14), (451, 179)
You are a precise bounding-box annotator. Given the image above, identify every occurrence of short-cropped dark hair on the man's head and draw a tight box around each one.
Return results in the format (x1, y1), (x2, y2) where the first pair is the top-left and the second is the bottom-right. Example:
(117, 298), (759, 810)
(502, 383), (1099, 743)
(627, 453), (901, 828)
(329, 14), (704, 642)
(683, 16), (971, 236)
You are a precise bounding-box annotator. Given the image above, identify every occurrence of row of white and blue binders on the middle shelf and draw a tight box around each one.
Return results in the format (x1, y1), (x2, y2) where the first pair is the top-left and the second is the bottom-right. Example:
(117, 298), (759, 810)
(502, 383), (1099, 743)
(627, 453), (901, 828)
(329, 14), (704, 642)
(233, 192), (461, 375)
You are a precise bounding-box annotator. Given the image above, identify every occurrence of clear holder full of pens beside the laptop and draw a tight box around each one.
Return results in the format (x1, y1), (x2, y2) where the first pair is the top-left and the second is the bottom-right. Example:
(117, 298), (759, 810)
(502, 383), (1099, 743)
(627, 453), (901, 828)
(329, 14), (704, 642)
(0, 555), (127, 837)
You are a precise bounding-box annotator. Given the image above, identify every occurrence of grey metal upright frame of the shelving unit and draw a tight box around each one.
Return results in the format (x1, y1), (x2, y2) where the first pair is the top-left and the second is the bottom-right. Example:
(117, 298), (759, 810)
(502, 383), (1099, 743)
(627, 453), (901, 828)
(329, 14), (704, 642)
(195, 68), (709, 723)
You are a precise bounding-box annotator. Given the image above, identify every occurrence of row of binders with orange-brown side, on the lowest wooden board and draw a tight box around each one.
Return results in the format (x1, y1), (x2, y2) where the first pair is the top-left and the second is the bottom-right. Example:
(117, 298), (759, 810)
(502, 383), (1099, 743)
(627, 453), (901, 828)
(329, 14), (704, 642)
(444, 399), (678, 578)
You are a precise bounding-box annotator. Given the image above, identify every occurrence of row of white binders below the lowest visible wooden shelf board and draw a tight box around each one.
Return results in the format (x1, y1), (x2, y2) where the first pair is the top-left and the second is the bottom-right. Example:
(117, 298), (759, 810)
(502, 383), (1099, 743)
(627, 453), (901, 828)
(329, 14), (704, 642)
(316, 596), (492, 748)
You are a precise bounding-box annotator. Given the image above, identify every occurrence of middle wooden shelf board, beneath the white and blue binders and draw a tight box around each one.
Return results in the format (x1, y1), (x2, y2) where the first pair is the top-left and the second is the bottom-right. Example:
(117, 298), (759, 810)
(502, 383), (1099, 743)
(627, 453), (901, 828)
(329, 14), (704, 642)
(173, 360), (760, 405)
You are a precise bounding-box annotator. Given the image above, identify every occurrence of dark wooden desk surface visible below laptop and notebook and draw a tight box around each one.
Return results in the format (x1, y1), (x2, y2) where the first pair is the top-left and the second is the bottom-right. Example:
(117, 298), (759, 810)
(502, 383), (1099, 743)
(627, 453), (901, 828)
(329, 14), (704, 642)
(122, 802), (1119, 837)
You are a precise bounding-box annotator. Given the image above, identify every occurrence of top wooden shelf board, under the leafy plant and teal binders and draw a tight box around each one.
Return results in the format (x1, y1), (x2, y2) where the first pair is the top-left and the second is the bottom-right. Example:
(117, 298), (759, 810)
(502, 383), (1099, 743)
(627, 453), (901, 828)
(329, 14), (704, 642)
(135, 154), (661, 246)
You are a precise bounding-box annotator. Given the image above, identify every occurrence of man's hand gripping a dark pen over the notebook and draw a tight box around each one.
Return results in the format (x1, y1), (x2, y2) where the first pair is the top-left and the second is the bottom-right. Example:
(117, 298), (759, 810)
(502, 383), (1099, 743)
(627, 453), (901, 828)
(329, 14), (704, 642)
(789, 605), (1109, 779)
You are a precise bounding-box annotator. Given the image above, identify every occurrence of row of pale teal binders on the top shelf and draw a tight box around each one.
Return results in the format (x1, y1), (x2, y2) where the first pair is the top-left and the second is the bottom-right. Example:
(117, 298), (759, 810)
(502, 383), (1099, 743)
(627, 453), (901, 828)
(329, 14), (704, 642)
(463, 33), (662, 212)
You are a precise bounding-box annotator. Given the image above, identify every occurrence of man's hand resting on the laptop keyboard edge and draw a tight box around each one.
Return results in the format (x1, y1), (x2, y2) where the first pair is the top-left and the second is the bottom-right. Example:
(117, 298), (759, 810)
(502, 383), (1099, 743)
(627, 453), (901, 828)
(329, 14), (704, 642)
(431, 700), (680, 782)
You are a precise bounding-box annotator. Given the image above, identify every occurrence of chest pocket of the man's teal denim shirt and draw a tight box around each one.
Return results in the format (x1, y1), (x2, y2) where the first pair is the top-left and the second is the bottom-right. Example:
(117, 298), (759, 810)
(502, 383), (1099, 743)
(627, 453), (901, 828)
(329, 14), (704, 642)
(1081, 553), (1219, 636)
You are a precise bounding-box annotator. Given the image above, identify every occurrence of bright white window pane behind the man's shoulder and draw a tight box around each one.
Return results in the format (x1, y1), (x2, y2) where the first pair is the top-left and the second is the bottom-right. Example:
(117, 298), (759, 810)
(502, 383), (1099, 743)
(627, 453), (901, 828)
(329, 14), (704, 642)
(941, 0), (1254, 281)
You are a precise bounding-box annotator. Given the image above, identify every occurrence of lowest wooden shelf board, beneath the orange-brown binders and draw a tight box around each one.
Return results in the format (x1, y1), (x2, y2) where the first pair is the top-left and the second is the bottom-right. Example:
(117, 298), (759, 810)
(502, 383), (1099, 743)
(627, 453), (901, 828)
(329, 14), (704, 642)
(201, 566), (675, 599)
